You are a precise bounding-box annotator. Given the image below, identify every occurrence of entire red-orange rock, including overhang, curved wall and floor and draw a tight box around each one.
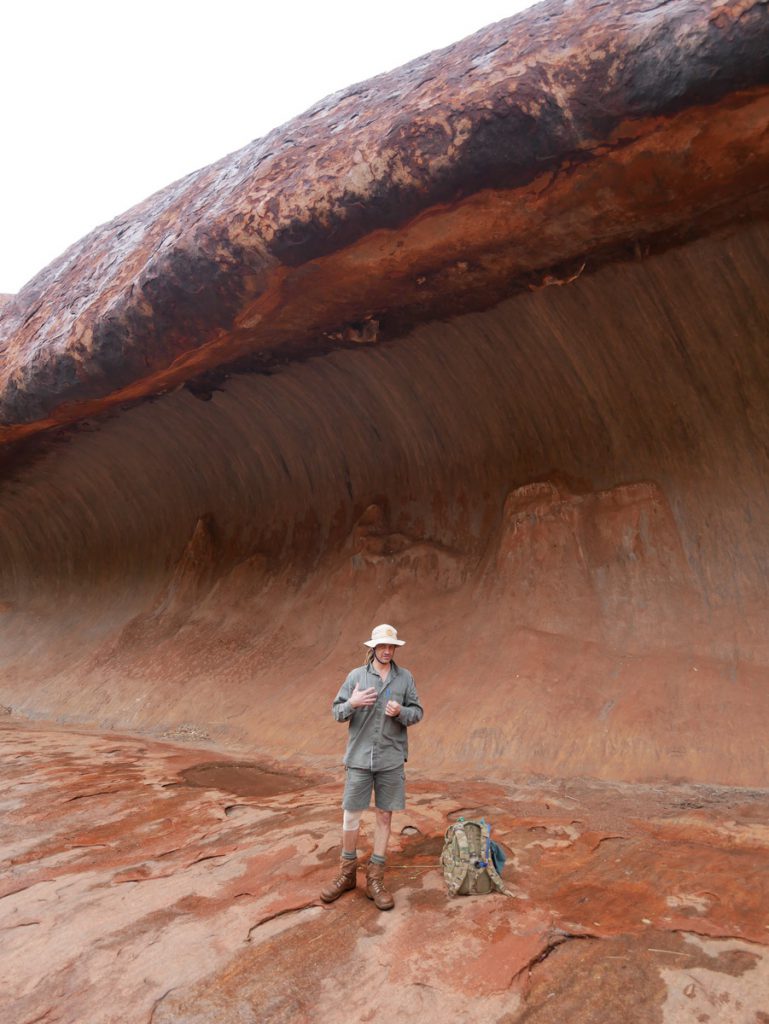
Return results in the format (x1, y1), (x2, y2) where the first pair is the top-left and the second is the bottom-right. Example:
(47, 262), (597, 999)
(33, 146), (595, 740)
(0, 6), (769, 1024)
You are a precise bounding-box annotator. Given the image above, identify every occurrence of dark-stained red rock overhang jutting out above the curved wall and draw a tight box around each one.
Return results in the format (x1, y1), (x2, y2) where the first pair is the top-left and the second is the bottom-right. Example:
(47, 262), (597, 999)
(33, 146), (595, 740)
(0, 0), (769, 443)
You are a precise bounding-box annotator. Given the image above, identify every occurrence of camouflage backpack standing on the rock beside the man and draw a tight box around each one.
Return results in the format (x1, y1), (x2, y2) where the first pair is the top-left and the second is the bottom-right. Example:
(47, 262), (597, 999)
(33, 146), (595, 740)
(440, 818), (513, 896)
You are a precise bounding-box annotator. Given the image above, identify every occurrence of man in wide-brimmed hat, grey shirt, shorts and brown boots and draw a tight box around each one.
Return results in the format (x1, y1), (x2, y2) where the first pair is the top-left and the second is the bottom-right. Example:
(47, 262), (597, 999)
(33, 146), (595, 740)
(321, 625), (423, 910)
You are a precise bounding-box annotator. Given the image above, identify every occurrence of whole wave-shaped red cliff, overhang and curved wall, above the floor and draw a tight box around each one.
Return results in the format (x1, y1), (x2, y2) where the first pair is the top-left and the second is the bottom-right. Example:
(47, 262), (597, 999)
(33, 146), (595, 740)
(0, 0), (769, 785)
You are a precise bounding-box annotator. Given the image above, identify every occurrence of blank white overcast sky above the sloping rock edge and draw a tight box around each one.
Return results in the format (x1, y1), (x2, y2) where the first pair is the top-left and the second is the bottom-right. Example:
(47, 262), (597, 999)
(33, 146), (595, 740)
(0, 0), (531, 293)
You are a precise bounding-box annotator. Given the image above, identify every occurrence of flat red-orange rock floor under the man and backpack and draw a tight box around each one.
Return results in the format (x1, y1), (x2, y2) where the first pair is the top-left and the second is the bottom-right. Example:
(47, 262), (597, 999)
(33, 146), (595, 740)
(0, 718), (769, 1024)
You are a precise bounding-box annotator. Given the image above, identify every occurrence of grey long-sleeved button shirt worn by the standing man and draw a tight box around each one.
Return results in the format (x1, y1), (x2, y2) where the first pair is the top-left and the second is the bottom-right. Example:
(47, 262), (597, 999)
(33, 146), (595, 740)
(331, 662), (424, 771)
